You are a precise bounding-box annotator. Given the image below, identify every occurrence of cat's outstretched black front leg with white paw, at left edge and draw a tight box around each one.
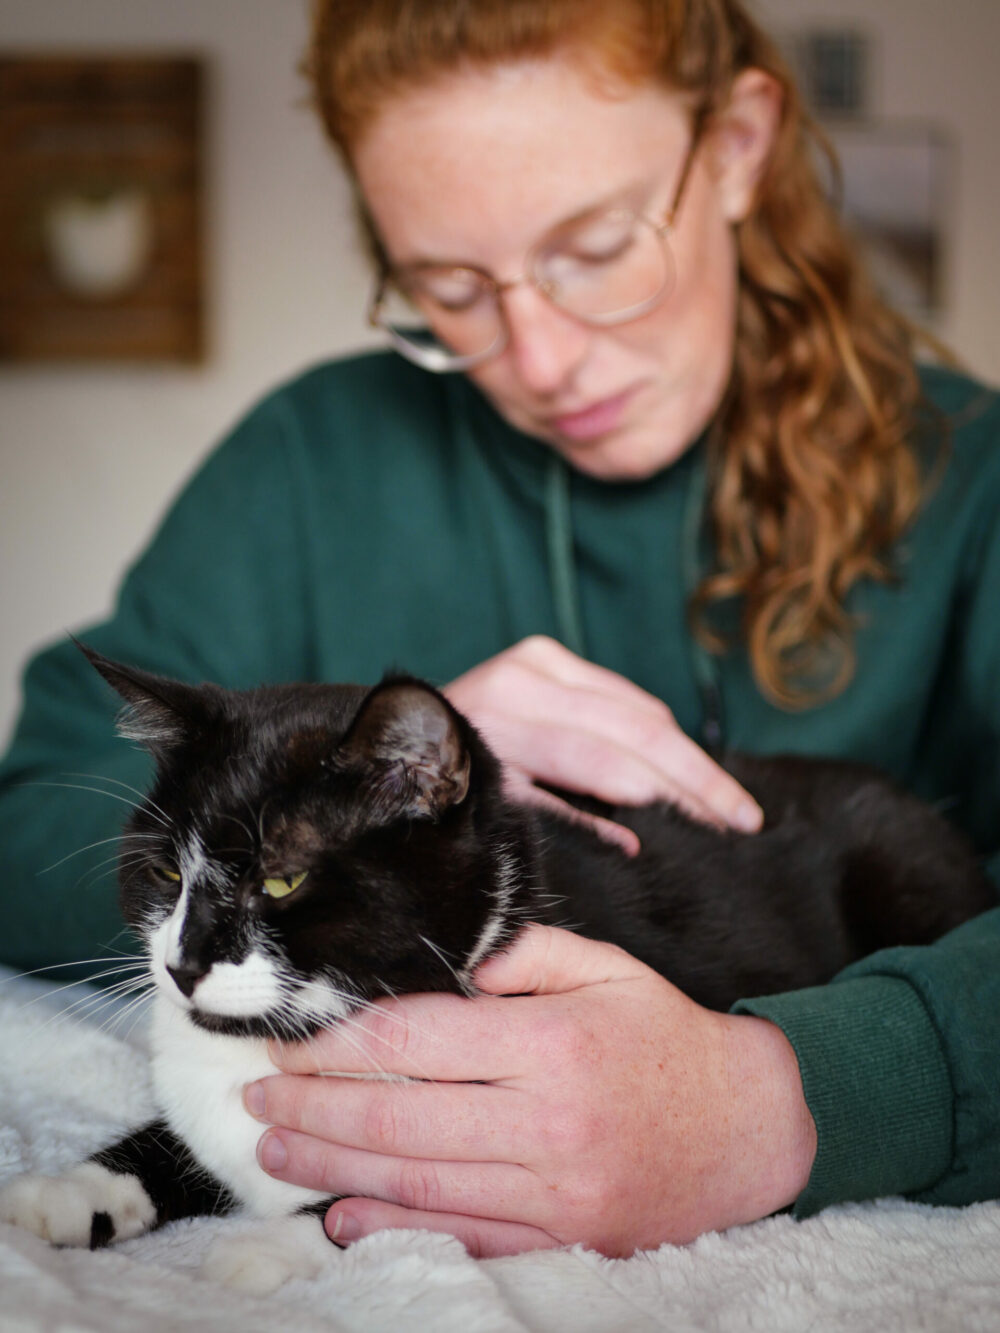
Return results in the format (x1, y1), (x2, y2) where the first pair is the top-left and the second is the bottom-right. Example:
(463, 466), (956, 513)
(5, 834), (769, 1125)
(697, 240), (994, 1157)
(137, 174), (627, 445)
(0, 1121), (235, 1249)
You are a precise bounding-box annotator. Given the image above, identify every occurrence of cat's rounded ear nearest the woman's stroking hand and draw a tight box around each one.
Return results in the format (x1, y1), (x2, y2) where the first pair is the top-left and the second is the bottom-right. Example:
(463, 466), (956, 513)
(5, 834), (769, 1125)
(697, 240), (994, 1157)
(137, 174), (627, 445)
(339, 680), (471, 818)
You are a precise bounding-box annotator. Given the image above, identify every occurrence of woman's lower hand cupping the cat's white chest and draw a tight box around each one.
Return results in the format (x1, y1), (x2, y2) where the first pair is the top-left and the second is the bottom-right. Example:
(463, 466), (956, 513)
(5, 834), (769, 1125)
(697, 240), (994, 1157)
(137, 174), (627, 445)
(247, 926), (815, 1256)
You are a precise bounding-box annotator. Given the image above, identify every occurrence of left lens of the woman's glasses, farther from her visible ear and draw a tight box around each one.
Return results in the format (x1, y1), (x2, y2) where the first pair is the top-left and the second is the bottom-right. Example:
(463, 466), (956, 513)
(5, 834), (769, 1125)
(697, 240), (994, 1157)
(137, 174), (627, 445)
(372, 268), (503, 371)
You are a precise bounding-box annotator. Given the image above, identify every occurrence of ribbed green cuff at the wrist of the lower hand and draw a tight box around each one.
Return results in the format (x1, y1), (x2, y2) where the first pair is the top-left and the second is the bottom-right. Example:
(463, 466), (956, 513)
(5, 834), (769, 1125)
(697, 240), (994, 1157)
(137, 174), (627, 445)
(732, 976), (953, 1217)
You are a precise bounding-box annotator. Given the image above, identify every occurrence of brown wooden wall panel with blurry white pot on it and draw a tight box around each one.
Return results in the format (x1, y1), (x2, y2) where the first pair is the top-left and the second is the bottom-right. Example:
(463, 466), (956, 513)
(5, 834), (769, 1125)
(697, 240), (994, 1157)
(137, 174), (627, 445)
(0, 53), (205, 363)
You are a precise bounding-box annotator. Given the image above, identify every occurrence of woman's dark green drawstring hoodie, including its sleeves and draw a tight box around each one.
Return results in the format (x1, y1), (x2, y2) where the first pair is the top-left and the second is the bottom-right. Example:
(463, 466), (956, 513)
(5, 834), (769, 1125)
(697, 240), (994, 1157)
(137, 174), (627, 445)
(0, 355), (1000, 1216)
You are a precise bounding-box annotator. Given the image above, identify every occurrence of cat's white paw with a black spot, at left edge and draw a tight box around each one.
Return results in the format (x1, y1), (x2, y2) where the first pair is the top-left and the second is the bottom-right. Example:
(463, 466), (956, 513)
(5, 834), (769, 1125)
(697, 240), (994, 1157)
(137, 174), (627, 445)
(0, 1162), (156, 1245)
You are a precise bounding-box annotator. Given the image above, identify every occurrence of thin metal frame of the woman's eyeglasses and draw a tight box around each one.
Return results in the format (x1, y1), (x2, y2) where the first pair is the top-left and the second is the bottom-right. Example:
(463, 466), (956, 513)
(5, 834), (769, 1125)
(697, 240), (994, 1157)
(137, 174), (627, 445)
(368, 117), (703, 375)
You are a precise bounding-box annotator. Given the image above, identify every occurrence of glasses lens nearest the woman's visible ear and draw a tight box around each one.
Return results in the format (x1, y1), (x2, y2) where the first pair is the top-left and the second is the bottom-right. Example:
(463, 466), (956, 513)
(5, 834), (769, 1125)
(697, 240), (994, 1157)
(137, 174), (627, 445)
(533, 209), (675, 324)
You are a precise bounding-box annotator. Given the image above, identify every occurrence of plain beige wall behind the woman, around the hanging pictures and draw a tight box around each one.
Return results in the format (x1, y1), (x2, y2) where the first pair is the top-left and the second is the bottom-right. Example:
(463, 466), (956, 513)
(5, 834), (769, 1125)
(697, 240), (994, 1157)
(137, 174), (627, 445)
(0, 0), (1000, 729)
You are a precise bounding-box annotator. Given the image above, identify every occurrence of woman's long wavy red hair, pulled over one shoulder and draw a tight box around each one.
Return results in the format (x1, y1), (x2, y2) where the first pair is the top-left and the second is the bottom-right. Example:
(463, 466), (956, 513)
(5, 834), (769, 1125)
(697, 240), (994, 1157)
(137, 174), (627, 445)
(305, 0), (924, 708)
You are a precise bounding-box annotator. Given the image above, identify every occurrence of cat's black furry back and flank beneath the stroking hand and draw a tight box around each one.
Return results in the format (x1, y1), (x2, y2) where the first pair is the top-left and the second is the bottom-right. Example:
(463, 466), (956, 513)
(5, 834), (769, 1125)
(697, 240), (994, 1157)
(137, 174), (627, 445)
(533, 754), (995, 1009)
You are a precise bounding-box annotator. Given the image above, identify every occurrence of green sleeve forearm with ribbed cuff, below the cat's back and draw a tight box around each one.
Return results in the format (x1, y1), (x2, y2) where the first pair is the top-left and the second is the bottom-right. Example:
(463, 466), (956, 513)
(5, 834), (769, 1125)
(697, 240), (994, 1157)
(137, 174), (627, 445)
(735, 908), (1000, 1217)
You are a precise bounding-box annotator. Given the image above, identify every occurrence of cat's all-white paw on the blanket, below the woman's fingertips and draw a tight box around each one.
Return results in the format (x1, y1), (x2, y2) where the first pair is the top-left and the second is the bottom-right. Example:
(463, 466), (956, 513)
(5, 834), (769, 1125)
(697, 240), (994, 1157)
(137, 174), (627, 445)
(201, 1216), (339, 1296)
